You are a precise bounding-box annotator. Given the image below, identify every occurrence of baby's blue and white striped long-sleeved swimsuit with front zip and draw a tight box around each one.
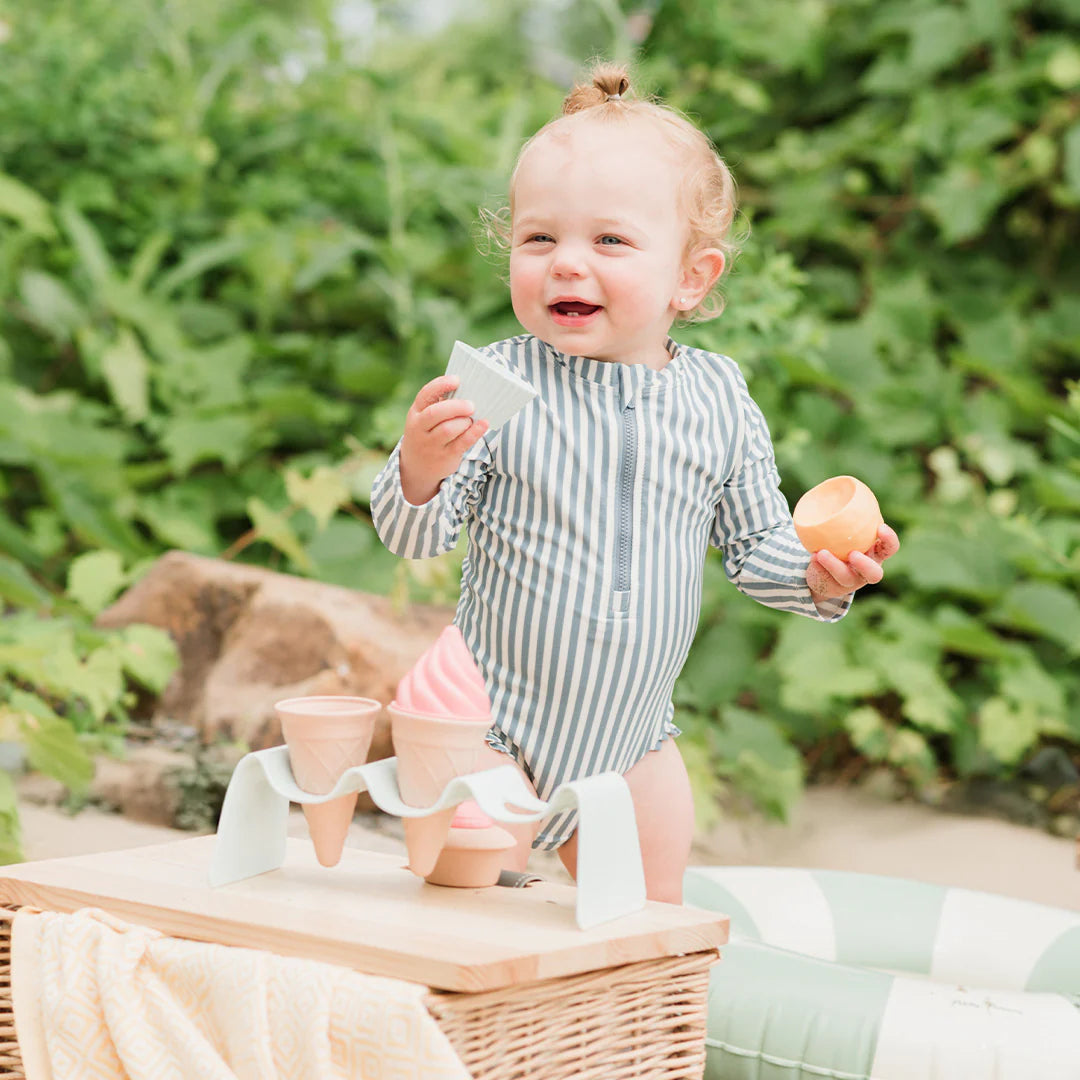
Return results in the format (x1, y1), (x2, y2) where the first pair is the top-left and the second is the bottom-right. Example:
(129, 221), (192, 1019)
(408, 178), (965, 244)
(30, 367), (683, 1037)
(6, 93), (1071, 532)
(372, 335), (850, 849)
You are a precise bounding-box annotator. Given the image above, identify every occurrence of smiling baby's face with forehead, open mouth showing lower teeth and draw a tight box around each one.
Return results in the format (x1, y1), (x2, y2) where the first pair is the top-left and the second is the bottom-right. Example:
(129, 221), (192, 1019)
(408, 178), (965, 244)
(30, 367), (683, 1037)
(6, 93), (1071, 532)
(510, 121), (688, 367)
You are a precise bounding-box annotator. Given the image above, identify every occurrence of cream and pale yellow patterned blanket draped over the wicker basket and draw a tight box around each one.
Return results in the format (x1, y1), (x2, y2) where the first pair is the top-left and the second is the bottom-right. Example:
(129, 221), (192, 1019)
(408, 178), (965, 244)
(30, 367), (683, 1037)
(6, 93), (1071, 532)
(12, 908), (469, 1080)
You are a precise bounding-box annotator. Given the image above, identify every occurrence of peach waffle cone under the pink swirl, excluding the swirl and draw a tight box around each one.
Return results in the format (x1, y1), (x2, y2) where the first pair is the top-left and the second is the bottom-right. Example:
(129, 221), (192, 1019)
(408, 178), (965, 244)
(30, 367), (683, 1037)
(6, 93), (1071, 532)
(389, 704), (491, 877)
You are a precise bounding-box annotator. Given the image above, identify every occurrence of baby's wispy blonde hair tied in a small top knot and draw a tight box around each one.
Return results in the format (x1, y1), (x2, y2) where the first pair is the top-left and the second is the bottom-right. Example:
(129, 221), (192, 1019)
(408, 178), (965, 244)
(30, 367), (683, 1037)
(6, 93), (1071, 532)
(481, 63), (738, 323)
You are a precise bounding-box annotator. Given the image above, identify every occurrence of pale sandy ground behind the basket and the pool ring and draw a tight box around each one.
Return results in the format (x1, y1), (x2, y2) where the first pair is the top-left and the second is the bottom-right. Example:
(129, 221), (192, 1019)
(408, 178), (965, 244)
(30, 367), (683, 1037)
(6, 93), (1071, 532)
(12, 788), (1080, 910)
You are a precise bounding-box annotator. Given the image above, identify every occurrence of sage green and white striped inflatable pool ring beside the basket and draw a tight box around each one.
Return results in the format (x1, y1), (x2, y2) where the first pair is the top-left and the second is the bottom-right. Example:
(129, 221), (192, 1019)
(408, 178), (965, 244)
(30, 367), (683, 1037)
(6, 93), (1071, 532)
(685, 866), (1080, 1080)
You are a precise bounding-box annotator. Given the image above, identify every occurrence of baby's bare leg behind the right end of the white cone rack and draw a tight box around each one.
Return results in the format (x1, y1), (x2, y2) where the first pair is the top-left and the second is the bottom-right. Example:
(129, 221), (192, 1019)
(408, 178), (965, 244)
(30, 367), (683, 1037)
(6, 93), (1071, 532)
(558, 739), (693, 904)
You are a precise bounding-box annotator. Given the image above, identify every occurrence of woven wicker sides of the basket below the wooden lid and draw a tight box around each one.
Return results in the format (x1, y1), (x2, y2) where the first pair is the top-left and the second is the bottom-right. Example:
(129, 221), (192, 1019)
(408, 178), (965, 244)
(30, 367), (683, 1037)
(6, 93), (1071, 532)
(0, 907), (716, 1080)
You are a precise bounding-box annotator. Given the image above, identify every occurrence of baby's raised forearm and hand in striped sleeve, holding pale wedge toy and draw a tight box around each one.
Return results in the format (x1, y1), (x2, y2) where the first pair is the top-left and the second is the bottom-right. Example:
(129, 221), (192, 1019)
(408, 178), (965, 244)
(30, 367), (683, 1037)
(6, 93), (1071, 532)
(372, 375), (491, 558)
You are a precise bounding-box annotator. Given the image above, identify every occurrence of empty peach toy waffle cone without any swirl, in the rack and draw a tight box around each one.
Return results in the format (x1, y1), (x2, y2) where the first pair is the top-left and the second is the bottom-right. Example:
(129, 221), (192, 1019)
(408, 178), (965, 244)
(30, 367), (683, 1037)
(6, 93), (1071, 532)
(274, 697), (382, 866)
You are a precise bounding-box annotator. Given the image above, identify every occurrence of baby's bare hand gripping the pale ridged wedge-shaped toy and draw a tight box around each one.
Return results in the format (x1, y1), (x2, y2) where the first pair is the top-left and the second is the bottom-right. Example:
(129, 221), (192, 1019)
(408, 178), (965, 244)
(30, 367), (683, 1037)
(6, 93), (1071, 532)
(400, 375), (487, 507)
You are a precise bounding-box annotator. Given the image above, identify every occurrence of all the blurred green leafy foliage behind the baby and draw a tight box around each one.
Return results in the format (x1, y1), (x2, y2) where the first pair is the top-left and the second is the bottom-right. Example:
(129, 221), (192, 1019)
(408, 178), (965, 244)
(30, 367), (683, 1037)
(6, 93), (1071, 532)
(0, 0), (1080, 858)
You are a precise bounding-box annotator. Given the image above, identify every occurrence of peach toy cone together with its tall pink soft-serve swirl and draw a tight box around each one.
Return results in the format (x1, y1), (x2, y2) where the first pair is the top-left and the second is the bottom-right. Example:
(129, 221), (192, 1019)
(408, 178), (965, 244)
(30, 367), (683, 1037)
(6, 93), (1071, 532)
(389, 625), (491, 877)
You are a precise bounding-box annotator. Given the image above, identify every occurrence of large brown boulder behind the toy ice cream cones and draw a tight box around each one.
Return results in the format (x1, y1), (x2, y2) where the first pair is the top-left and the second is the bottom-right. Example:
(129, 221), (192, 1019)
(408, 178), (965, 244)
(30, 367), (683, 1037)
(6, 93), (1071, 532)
(97, 552), (453, 760)
